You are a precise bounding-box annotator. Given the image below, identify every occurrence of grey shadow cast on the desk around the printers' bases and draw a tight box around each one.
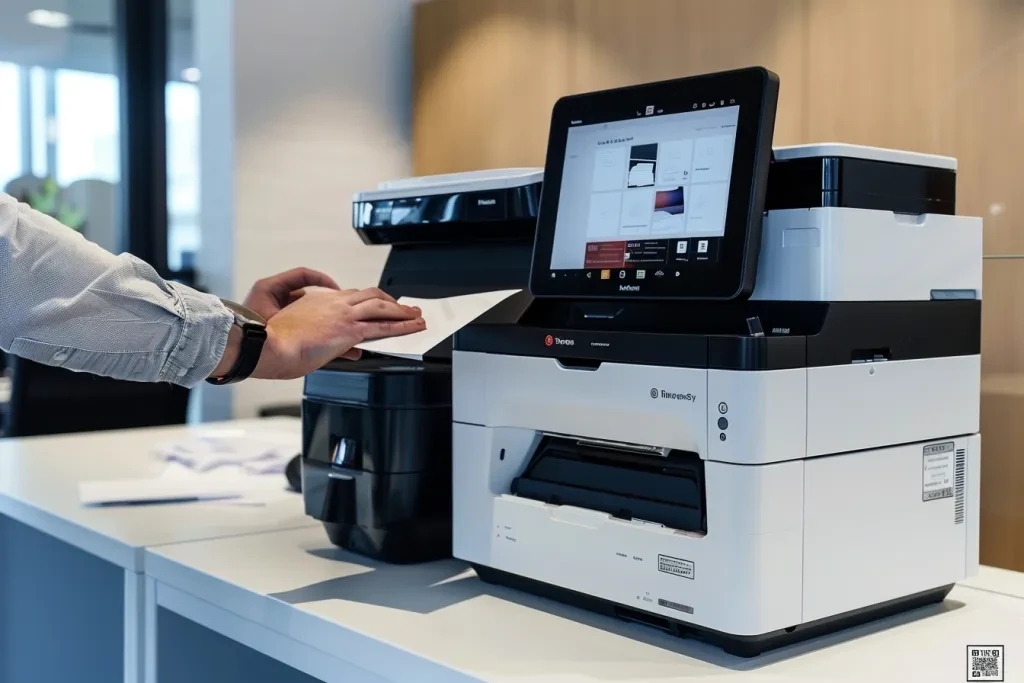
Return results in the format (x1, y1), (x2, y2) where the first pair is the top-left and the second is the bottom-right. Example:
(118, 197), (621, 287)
(271, 548), (964, 671)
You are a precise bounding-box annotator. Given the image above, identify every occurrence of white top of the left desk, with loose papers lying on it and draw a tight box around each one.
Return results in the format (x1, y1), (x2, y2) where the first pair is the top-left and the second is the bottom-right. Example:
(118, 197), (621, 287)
(0, 418), (319, 571)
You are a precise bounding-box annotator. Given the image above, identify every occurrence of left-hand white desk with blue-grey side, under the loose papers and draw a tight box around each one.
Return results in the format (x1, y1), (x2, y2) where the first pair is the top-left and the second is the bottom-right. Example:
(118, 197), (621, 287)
(0, 419), (314, 683)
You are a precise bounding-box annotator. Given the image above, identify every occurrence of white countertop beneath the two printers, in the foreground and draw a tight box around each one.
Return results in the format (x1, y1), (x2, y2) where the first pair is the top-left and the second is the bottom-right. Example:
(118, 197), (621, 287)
(146, 528), (1024, 683)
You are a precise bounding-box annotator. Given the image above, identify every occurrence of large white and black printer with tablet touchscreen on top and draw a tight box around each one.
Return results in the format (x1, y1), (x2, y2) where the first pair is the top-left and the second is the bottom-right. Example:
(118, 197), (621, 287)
(453, 72), (982, 656)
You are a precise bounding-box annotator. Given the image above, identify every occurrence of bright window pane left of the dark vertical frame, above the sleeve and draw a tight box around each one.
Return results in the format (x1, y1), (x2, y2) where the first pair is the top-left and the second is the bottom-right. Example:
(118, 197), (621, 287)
(0, 0), (126, 251)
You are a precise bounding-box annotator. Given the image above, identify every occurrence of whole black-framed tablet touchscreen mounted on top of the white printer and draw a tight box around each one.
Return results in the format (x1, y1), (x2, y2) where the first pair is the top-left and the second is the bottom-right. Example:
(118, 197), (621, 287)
(530, 69), (778, 299)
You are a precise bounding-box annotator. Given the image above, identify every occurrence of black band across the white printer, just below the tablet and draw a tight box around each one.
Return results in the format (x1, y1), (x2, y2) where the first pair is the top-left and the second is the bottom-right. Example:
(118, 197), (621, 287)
(455, 300), (981, 371)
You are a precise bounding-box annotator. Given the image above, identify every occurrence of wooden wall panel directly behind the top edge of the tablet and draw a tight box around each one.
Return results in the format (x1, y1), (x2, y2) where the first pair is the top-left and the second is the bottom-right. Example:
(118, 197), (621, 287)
(571, 0), (807, 144)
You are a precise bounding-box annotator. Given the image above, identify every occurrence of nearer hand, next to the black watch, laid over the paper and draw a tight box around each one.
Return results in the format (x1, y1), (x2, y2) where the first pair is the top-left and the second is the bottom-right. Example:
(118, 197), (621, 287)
(252, 286), (427, 380)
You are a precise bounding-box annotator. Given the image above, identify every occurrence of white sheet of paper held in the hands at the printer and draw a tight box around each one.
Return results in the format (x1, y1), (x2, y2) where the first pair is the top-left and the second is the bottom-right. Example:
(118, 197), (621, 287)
(356, 290), (521, 360)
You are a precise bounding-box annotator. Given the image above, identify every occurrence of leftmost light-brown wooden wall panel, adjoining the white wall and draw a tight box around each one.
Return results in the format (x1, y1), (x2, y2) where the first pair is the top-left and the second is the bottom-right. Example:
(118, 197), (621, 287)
(413, 0), (571, 175)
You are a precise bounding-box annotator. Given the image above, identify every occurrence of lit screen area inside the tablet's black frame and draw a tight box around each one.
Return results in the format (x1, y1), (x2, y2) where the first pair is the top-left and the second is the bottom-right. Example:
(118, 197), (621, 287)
(550, 105), (739, 284)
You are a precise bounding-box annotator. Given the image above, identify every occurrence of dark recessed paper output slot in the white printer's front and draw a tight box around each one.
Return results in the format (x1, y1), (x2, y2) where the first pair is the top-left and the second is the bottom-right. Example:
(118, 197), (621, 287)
(512, 435), (708, 533)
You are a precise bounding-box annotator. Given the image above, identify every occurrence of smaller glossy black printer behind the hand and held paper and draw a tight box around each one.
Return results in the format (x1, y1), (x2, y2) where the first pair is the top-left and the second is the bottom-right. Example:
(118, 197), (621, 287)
(302, 169), (543, 562)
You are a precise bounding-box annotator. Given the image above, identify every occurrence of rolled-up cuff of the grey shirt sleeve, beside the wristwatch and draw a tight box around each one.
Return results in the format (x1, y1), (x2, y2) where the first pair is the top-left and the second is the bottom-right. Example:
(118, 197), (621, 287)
(160, 283), (234, 387)
